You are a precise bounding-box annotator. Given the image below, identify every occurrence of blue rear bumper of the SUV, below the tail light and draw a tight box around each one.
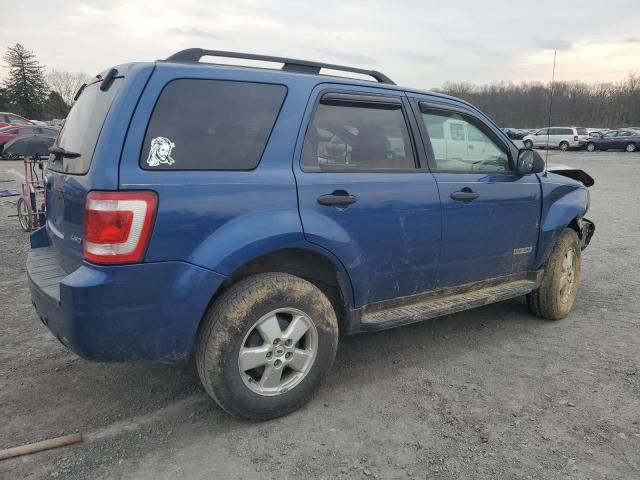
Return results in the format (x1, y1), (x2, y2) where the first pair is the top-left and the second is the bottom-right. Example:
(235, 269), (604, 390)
(27, 232), (224, 361)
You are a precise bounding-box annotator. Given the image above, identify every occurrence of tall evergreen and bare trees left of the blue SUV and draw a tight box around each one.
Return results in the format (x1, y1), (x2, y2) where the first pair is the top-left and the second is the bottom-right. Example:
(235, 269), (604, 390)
(0, 43), (88, 120)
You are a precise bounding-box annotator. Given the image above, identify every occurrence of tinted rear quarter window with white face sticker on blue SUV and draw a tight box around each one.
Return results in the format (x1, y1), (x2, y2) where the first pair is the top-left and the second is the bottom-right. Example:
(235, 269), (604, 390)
(140, 79), (287, 170)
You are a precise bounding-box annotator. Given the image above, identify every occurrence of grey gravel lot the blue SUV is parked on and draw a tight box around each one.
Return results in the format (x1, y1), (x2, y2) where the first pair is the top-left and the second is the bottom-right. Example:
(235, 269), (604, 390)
(0, 148), (640, 479)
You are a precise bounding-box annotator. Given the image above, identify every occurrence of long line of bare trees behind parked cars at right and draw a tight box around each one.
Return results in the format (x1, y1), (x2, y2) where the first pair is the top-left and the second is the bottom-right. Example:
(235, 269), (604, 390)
(437, 73), (640, 128)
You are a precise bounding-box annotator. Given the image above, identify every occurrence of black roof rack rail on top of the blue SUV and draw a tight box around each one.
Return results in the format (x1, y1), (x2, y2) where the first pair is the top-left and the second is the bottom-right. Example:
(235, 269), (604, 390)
(165, 48), (395, 85)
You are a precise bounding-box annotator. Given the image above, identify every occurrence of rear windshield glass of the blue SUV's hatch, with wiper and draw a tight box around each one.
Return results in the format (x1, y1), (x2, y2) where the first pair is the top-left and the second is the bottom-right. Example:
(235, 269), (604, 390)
(48, 77), (122, 175)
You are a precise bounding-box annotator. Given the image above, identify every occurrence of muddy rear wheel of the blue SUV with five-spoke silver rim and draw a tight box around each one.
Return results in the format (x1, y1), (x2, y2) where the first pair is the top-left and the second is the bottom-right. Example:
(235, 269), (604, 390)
(196, 273), (338, 420)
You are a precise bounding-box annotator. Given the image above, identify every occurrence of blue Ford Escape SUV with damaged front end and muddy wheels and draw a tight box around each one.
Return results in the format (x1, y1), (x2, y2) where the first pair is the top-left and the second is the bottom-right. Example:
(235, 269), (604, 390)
(27, 49), (594, 420)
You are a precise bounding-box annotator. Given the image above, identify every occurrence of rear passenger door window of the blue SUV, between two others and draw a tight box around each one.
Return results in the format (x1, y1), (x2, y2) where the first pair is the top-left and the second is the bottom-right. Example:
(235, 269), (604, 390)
(301, 98), (416, 172)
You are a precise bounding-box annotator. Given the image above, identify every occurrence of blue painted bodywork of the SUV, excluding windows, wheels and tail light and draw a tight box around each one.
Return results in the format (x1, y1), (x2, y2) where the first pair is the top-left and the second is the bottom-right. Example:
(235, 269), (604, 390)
(30, 58), (587, 361)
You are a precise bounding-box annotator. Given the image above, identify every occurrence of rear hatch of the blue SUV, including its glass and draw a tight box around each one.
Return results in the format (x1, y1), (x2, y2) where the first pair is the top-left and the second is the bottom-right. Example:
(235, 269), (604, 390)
(45, 76), (124, 273)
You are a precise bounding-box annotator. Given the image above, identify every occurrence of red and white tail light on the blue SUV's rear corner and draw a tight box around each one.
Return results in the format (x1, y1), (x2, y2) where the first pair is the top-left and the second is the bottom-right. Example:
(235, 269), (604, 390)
(83, 191), (158, 265)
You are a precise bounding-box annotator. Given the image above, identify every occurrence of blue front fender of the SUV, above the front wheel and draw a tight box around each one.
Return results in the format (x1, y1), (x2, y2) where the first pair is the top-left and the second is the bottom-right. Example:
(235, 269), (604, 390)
(535, 173), (589, 267)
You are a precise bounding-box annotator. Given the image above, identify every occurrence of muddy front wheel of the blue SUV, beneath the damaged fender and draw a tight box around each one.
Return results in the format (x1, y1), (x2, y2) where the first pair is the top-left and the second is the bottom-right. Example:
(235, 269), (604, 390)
(527, 228), (581, 320)
